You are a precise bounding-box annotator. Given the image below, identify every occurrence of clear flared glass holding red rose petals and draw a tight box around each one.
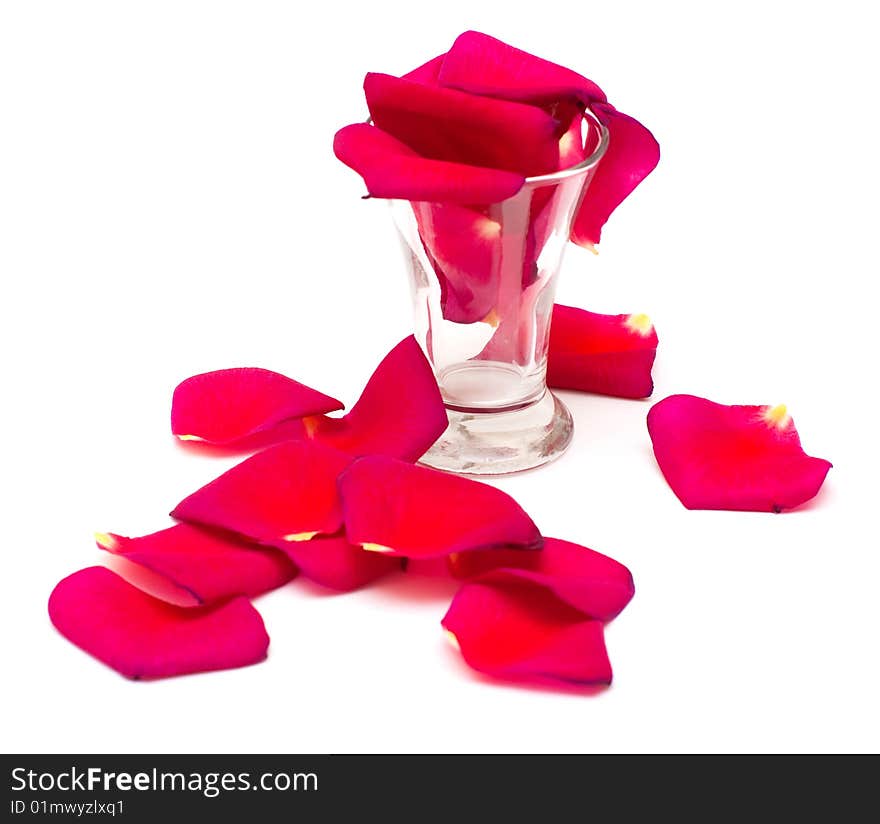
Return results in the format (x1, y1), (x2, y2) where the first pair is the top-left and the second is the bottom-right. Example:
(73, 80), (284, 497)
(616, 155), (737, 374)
(391, 112), (608, 475)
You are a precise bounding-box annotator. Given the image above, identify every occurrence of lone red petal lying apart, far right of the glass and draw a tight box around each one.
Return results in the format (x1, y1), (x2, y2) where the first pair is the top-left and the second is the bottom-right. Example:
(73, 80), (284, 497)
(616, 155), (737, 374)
(648, 395), (831, 512)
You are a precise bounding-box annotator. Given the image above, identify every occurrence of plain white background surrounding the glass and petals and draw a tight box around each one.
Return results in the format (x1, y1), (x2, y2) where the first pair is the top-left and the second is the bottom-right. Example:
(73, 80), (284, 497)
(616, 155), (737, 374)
(0, 0), (880, 752)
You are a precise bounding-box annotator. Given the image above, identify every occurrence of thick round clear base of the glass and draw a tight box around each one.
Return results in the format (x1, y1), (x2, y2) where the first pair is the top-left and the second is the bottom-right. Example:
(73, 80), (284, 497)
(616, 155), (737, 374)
(420, 391), (573, 475)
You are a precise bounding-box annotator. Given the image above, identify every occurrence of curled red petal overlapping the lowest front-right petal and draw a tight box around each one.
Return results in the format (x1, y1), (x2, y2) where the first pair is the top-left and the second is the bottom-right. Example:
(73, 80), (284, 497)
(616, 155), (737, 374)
(449, 538), (635, 621)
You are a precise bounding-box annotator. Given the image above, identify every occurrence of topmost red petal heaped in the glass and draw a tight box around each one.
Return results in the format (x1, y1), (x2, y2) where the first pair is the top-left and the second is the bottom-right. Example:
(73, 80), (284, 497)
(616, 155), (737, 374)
(439, 31), (606, 104)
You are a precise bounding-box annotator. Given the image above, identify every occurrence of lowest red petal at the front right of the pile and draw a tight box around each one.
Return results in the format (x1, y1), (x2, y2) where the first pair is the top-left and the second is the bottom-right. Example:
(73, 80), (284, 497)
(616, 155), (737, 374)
(442, 580), (611, 685)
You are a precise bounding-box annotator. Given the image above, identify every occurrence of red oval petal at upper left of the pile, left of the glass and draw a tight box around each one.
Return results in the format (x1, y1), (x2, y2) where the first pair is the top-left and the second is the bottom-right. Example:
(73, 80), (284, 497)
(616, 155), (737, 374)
(171, 367), (343, 444)
